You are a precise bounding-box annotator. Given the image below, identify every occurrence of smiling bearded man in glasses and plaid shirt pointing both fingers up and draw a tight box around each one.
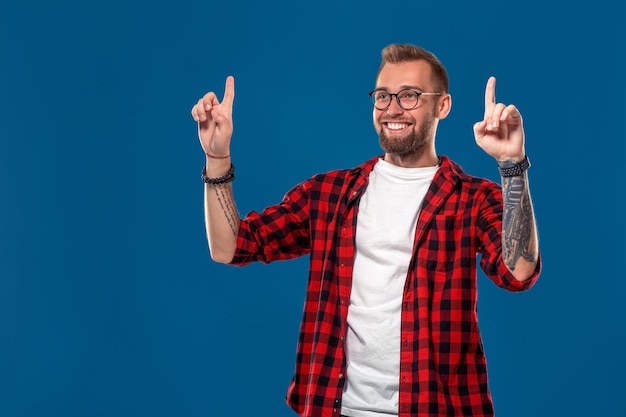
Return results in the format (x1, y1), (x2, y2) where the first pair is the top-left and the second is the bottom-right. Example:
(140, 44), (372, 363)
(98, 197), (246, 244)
(192, 45), (540, 417)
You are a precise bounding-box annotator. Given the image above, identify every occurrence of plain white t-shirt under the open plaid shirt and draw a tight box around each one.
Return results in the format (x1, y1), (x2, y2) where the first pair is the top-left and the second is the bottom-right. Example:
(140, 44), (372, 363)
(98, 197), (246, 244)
(341, 159), (439, 417)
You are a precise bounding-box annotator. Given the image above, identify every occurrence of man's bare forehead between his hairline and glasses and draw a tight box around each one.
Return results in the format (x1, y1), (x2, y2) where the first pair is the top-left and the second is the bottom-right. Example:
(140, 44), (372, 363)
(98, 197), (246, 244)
(376, 60), (433, 90)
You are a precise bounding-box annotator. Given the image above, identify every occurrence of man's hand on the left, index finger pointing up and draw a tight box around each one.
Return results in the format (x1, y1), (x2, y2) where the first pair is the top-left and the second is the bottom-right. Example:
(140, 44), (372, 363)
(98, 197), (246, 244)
(191, 76), (235, 158)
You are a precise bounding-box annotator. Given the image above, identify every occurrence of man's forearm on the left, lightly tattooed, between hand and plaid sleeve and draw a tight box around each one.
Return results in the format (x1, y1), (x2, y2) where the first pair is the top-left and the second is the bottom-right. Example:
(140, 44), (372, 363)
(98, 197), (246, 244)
(204, 158), (240, 263)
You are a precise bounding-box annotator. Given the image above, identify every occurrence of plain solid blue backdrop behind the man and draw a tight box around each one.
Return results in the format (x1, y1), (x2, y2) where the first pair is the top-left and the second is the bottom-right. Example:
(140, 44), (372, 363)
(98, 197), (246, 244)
(0, 0), (626, 417)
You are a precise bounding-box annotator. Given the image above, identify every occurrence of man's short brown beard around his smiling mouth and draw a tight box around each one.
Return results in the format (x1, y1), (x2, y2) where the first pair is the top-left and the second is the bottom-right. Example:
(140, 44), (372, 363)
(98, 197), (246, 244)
(378, 114), (436, 158)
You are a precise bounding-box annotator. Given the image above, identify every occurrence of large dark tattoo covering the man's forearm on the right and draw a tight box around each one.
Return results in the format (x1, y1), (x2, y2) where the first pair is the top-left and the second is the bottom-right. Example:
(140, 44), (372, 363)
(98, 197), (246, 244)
(502, 173), (537, 271)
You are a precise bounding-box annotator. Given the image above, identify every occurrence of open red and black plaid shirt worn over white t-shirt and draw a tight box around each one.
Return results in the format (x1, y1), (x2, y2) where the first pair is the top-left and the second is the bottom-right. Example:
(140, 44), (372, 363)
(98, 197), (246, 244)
(232, 157), (540, 417)
